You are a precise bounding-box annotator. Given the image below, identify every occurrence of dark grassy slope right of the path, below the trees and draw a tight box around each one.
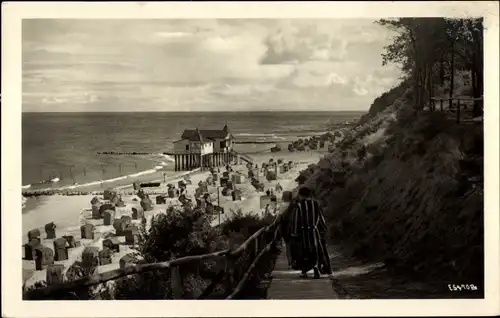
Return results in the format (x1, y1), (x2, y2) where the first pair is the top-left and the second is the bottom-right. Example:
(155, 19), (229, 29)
(298, 84), (483, 294)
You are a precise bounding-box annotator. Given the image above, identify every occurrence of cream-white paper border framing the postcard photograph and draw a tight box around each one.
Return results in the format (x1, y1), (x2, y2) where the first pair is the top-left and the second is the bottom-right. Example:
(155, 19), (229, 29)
(2, 1), (500, 317)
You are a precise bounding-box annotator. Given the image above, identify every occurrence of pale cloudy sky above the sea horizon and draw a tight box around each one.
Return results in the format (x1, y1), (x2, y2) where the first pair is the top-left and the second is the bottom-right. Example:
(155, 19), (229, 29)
(22, 19), (400, 112)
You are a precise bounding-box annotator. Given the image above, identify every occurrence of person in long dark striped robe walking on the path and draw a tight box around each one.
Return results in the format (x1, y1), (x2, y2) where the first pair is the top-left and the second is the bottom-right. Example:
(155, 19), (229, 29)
(284, 187), (331, 278)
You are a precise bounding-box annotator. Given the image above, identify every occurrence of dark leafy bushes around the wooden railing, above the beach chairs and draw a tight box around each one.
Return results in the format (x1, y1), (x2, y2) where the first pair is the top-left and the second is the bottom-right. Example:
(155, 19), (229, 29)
(25, 206), (279, 300)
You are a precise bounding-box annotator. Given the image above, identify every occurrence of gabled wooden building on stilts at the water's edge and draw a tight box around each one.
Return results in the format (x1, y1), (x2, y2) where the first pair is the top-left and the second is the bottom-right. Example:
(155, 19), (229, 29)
(173, 125), (234, 171)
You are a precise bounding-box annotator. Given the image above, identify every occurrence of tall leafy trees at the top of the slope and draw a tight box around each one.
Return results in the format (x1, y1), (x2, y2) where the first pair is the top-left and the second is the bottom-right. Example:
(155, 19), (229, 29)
(378, 18), (484, 116)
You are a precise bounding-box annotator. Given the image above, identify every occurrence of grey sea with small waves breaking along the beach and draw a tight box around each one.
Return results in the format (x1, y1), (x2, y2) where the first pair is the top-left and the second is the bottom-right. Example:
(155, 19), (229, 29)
(22, 111), (363, 189)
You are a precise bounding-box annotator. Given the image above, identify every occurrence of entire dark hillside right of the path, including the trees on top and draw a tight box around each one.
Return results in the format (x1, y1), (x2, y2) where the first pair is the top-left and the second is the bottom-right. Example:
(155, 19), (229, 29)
(294, 18), (484, 297)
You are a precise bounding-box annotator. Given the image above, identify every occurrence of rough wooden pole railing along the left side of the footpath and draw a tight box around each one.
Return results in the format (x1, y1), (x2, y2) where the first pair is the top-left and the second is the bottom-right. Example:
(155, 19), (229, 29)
(26, 202), (288, 299)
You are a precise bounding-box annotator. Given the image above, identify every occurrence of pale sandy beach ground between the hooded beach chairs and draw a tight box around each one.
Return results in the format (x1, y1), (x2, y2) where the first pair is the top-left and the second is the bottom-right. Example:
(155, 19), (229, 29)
(22, 147), (327, 286)
